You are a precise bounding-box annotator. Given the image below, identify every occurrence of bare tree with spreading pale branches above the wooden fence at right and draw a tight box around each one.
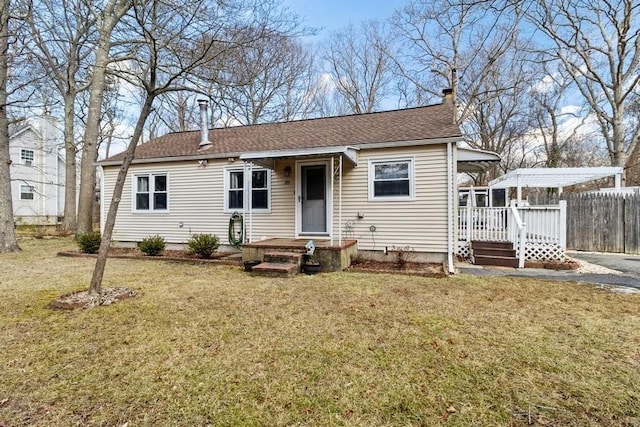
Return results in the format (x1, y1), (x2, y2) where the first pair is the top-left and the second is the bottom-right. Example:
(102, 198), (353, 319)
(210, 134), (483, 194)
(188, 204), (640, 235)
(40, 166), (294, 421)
(526, 0), (640, 174)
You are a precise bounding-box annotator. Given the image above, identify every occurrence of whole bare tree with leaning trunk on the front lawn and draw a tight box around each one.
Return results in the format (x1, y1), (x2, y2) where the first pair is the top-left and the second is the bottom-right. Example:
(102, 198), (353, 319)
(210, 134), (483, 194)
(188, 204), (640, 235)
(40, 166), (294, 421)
(89, 0), (298, 294)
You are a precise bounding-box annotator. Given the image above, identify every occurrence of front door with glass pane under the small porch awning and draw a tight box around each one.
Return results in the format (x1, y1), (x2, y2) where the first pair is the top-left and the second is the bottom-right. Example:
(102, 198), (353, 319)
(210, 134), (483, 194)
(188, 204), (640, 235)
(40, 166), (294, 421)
(300, 165), (327, 234)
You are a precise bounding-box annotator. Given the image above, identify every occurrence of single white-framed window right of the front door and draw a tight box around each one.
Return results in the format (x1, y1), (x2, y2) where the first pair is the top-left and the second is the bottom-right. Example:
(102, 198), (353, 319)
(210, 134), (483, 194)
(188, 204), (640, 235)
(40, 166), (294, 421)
(369, 159), (414, 200)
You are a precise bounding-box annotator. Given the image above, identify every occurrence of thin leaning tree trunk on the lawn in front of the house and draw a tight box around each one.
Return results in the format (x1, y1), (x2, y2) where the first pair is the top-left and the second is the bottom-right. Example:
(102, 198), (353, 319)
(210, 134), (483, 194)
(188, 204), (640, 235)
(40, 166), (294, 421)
(89, 94), (155, 294)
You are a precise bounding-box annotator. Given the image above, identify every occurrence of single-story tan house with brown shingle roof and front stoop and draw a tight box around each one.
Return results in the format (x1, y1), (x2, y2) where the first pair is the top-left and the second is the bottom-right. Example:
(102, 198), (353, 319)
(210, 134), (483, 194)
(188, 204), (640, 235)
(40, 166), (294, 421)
(98, 91), (499, 270)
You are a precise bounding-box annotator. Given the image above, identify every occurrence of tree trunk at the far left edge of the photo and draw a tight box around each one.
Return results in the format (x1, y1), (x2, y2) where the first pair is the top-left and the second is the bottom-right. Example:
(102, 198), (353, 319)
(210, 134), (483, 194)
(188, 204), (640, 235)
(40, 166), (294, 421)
(0, 0), (20, 252)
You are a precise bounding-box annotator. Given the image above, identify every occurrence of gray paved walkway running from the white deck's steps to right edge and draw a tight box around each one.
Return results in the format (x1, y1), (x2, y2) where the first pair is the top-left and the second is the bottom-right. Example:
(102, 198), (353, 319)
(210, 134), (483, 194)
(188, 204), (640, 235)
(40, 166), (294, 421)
(457, 252), (640, 292)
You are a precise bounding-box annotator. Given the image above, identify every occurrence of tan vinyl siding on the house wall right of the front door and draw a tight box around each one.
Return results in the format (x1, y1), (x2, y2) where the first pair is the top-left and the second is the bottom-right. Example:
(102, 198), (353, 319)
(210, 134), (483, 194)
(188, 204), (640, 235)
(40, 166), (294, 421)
(334, 144), (447, 253)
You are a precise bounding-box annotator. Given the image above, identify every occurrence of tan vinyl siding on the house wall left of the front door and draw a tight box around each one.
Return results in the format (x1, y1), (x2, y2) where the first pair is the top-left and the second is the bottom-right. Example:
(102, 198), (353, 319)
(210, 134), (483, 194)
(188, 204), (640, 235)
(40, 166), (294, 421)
(103, 161), (295, 244)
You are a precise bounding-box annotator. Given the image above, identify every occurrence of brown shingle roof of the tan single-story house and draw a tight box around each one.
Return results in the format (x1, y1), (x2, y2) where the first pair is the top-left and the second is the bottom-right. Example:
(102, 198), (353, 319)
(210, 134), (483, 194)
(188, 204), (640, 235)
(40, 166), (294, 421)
(103, 103), (461, 162)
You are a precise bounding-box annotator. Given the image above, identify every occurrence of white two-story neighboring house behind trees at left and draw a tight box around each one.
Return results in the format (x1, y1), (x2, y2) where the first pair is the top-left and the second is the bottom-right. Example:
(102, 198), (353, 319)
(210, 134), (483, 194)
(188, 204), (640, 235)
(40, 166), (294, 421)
(9, 116), (65, 225)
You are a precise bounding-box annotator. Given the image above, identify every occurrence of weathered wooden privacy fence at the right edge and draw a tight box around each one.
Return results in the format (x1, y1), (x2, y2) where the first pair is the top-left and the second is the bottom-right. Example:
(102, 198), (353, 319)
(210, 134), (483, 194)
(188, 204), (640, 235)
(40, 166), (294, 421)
(565, 193), (640, 254)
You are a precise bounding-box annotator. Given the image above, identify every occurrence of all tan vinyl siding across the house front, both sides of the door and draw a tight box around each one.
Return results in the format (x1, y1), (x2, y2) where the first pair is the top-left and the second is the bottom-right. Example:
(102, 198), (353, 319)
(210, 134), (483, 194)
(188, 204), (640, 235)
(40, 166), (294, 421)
(103, 144), (447, 254)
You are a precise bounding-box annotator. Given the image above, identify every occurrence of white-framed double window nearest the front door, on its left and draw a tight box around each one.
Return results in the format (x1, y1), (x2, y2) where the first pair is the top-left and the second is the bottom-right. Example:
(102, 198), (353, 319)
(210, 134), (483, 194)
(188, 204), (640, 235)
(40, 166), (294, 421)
(225, 168), (271, 211)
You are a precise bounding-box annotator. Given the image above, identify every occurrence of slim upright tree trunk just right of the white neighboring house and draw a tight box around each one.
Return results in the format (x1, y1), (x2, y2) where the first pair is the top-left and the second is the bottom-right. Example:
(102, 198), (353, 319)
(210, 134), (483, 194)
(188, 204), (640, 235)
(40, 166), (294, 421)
(62, 91), (77, 233)
